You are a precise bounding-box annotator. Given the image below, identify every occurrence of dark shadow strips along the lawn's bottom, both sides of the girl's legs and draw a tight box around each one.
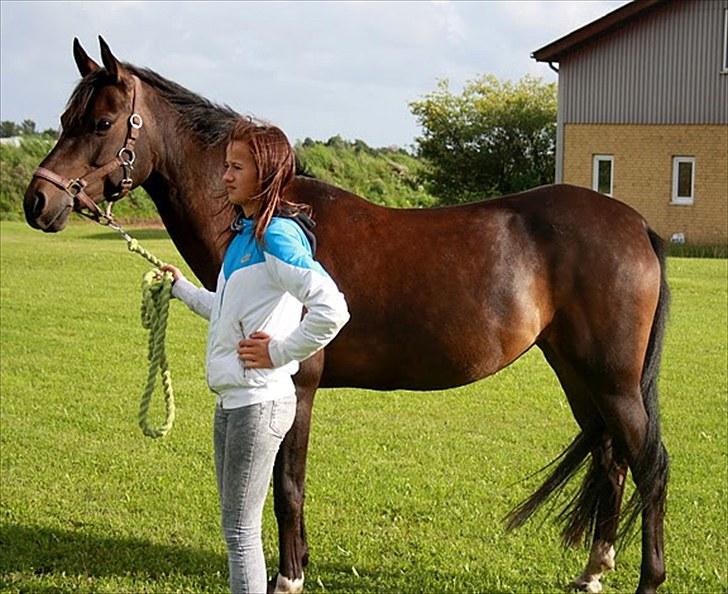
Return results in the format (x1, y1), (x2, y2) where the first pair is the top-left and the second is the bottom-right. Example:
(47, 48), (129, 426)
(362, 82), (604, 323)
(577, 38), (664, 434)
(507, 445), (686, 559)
(0, 524), (552, 594)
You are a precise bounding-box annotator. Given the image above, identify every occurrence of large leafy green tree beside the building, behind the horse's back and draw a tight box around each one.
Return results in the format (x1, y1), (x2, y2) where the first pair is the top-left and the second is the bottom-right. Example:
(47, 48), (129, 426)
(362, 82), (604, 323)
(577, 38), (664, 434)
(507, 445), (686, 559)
(410, 75), (556, 204)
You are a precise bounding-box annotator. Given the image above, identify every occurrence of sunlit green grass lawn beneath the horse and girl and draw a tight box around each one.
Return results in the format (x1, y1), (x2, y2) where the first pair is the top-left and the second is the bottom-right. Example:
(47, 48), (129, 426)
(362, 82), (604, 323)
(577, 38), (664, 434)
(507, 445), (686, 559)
(0, 223), (728, 593)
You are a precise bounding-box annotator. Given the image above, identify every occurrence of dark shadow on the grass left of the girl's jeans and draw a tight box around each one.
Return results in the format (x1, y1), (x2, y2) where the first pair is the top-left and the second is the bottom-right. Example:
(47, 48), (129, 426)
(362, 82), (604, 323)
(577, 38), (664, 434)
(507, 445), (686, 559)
(0, 524), (227, 584)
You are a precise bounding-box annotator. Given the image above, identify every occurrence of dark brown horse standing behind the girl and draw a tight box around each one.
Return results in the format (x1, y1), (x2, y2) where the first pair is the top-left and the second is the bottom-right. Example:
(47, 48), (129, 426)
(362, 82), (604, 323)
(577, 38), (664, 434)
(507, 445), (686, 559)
(24, 40), (668, 592)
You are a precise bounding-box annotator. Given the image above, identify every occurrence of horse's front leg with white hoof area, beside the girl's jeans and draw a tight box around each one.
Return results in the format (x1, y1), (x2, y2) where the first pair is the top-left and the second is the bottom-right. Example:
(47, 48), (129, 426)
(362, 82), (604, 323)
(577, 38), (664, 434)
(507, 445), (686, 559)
(269, 351), (324, 594)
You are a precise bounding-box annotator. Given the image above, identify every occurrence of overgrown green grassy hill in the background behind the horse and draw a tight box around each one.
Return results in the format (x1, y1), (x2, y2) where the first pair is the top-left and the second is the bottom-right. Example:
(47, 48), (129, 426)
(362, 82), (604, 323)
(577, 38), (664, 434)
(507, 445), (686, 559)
(0, 135), (436, 221)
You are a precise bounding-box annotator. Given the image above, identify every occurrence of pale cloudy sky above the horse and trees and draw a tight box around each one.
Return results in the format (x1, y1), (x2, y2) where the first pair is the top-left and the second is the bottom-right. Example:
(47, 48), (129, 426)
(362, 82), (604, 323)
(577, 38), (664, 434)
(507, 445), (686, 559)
(0, 0), (626, 148)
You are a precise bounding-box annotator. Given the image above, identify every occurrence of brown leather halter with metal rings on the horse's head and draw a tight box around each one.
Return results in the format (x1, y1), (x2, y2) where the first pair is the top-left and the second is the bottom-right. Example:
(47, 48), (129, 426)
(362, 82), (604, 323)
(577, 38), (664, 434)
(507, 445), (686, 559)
(33, 76), (144, 222)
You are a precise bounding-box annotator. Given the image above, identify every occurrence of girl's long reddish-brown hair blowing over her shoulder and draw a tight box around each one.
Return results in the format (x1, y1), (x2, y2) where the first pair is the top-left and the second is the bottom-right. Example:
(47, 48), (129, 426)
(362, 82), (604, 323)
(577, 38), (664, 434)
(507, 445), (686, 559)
(228, 119), (310, 244)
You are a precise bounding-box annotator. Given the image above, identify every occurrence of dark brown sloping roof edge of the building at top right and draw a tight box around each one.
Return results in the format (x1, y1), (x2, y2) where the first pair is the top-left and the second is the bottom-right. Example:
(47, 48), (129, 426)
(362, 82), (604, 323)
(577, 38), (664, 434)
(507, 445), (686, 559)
(531, 0), (668, 62)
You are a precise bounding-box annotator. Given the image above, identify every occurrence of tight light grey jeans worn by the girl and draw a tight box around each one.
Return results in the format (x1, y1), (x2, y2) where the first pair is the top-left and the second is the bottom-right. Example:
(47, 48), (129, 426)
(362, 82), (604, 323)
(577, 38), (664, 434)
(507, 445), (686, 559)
(214, 395), (296, 594)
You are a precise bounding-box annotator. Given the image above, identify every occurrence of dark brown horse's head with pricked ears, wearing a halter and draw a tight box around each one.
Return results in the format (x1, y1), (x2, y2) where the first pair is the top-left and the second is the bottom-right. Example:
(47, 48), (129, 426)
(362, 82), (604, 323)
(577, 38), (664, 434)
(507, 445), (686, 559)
(23, 37), (154, 232)
